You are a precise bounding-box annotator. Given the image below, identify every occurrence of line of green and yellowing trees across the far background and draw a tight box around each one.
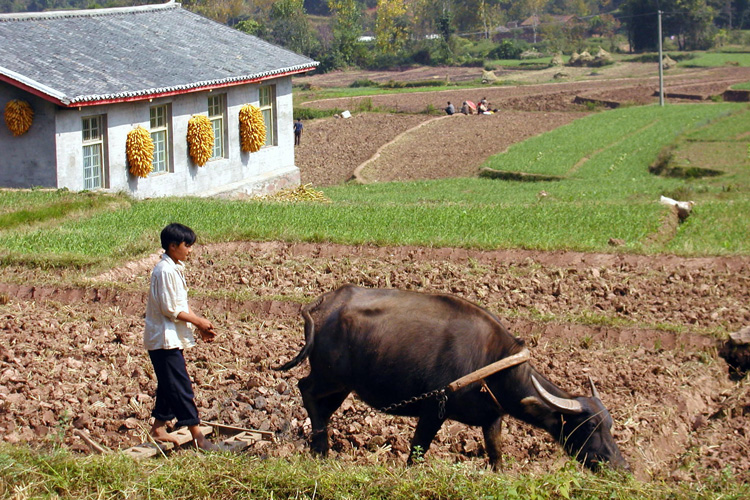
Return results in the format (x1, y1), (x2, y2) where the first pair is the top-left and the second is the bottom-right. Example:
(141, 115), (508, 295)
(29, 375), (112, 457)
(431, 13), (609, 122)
(5, 0), (750, 69)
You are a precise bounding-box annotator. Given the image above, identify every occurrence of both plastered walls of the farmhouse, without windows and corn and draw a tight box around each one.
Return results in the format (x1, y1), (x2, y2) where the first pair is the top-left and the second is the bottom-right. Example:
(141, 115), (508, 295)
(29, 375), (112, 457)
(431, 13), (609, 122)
(0, 77), (300, 198)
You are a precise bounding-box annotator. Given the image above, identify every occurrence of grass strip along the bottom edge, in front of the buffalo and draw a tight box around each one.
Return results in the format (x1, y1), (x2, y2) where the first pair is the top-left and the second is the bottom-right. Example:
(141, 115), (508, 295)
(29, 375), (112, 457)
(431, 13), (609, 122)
(0, 445), (750, 500)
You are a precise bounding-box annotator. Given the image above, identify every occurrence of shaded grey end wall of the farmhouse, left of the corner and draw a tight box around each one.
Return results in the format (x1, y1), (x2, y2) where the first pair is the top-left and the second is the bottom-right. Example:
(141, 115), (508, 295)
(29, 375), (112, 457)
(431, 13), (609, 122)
(0, 82), (57, 188)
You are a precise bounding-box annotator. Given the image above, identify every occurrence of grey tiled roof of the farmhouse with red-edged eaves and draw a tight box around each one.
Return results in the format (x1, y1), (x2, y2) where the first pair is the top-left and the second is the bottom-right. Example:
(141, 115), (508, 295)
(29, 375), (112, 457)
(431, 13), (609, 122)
(0, 3), (317, 105)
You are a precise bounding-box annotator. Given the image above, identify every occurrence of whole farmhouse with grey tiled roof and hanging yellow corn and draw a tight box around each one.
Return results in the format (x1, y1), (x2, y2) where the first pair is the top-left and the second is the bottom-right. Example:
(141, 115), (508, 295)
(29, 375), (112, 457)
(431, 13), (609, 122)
(0, 2), (318, 198)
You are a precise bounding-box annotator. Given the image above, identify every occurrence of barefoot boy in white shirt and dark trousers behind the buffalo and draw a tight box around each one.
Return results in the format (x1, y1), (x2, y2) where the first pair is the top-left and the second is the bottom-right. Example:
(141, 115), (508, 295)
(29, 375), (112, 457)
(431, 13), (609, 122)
(143, 223), (220, 451)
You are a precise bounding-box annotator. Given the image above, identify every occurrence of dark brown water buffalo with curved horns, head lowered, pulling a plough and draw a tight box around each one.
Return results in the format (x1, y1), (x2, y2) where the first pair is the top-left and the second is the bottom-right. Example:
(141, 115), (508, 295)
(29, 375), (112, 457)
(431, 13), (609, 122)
(277, 285), (628, 469)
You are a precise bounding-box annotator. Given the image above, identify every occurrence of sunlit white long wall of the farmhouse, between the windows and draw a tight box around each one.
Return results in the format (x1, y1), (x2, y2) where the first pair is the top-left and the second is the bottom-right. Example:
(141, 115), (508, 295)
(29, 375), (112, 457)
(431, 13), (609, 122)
(51, 77), (299, 198)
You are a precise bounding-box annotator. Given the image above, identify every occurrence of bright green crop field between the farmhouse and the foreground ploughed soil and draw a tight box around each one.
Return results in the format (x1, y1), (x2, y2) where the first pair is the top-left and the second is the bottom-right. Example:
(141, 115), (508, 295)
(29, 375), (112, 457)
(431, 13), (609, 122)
(0, 104), (750, 267)
